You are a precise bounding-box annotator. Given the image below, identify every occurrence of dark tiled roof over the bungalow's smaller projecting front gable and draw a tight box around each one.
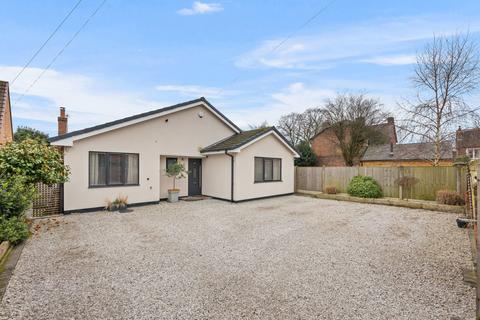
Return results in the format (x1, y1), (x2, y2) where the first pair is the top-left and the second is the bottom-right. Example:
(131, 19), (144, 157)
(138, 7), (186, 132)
(200, 127), (295, 153)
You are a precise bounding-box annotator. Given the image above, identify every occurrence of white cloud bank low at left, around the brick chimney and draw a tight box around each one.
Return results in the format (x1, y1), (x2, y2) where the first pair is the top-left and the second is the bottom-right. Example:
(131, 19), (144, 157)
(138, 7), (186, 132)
(0, 66), (168, 132)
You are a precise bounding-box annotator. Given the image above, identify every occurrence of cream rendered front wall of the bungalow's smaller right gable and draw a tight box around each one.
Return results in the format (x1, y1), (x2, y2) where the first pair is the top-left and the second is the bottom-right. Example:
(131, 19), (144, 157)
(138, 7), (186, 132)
(234, 135), (295, 201)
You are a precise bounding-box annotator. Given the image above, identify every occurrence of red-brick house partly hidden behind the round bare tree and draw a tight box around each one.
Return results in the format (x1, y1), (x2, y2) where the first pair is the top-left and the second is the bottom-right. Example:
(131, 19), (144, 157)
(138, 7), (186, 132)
(310, 117), (397, 167)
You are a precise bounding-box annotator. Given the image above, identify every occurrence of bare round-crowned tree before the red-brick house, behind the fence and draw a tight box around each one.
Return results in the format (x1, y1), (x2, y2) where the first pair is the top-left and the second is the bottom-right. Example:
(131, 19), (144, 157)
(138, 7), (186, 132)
(322, 94), (387, 166)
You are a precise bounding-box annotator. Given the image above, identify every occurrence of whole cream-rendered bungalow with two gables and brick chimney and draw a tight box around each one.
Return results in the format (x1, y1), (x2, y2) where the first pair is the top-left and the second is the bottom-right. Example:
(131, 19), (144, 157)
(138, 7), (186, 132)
(50, 97), (298, 212)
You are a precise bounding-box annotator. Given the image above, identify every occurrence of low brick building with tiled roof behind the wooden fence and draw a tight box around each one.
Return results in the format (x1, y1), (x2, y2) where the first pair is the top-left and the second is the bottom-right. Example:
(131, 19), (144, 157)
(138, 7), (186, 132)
(360, 143), (453, 167)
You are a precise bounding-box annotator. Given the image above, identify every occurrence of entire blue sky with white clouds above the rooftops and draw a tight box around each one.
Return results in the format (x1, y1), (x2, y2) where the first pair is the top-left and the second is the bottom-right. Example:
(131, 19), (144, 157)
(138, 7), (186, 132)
(0, 0), (480, 135)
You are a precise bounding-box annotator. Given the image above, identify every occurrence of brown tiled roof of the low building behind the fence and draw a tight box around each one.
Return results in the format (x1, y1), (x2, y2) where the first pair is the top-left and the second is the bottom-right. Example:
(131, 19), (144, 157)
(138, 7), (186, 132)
(362, 142), (453, 161)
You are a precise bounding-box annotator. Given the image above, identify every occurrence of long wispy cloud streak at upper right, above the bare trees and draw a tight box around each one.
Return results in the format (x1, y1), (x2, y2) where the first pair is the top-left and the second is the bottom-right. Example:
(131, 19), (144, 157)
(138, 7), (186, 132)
(235, 16), (480, 69)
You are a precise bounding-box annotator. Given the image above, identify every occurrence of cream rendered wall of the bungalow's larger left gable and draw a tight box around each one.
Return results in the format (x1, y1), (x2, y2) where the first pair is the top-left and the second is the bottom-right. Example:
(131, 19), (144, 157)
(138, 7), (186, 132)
(64, 105), (234, 211)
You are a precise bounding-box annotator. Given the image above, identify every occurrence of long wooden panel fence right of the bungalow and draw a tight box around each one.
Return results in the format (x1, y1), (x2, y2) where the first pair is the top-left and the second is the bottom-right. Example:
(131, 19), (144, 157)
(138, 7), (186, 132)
(295, 167), (465, 200)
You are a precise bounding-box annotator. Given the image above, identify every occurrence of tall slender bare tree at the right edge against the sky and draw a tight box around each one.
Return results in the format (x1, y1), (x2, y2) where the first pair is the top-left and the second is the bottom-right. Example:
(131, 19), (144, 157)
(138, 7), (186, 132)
(399, 35), (480, 165)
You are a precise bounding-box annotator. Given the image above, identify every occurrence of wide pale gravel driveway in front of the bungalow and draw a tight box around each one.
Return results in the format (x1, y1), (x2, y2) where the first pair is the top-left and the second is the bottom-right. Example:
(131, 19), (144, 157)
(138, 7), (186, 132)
(0, 196), (475, 320)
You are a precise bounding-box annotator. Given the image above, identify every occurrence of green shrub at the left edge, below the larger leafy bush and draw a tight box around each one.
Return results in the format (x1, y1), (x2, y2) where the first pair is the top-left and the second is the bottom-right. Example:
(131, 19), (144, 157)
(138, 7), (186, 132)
(0, 176), (36, 219)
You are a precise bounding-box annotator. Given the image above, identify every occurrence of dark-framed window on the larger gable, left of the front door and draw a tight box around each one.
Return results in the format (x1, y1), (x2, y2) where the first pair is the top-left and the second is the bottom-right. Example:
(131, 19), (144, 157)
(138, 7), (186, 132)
(89, 152), (139, 187)
